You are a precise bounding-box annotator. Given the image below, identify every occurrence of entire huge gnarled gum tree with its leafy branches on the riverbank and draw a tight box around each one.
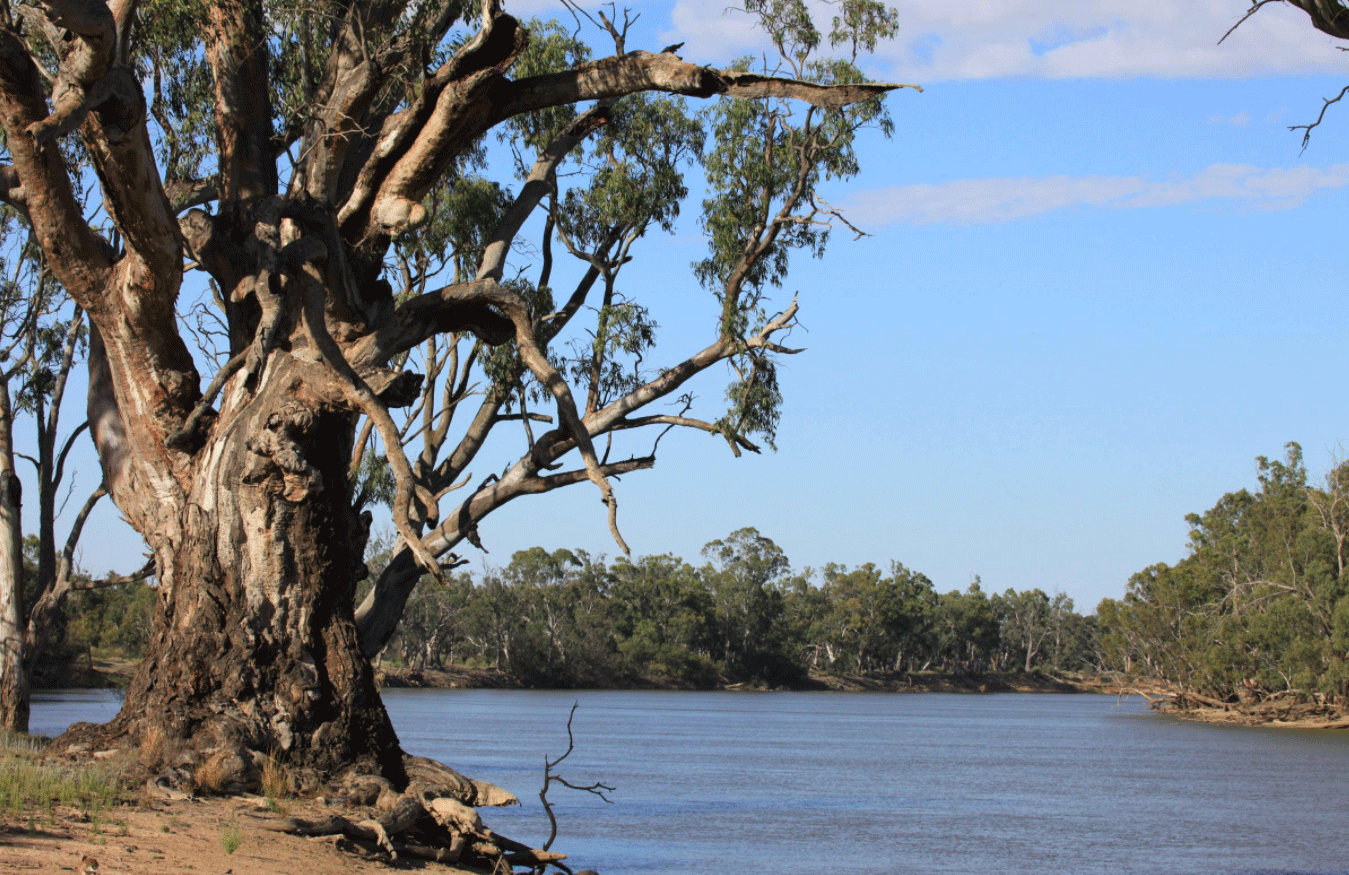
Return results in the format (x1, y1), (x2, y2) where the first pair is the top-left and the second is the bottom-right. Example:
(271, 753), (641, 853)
(0, 0), (894, 825)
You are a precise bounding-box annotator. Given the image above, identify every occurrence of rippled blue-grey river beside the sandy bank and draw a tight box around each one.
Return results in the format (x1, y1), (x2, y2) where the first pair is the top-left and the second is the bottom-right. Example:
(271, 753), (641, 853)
(32, 690), (1349, 875)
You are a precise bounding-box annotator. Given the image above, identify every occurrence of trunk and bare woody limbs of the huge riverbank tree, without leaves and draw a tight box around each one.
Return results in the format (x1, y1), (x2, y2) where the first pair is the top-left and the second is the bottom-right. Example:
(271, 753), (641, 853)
(0, 0), (893, 783)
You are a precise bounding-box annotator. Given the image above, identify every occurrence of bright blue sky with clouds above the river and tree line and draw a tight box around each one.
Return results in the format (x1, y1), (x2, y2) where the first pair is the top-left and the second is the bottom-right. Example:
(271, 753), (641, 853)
(55, 0), (1349, 609)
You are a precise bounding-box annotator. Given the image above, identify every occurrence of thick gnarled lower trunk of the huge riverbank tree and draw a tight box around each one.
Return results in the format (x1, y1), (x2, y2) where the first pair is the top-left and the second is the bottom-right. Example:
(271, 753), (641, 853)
(86, 333), (402, 779)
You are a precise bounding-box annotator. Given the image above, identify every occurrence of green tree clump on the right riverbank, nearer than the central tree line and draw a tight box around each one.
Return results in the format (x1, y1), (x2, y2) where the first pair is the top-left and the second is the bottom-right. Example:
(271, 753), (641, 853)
(1097, 444), (1349, 705)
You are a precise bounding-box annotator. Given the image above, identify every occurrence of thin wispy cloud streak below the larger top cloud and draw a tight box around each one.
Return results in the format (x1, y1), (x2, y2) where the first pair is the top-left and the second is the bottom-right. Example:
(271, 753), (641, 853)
(843, 164), (1349, 228)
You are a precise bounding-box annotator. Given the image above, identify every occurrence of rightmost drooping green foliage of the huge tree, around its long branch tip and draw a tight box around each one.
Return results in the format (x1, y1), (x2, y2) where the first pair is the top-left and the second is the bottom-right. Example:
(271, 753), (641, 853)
(693, 18), (894, 446)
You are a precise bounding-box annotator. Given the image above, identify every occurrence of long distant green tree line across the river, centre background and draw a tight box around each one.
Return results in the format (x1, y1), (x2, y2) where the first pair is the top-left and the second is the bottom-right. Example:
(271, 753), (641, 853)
(372, 529), (1095, 686)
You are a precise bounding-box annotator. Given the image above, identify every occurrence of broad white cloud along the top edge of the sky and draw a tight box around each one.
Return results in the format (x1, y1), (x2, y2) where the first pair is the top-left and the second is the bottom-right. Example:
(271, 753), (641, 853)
(666, 0), (1349, 82)
